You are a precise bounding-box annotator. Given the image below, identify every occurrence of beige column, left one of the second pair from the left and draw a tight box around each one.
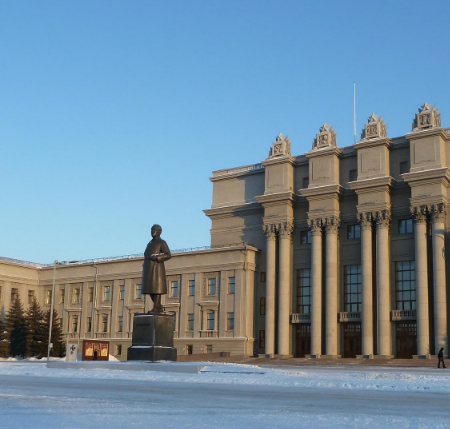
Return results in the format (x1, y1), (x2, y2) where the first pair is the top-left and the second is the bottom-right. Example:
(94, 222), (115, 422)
(308, 219), (322, 357)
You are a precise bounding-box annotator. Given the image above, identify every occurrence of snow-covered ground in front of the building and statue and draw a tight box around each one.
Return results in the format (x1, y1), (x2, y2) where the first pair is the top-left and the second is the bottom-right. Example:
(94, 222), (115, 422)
(0, 361), (450, 429)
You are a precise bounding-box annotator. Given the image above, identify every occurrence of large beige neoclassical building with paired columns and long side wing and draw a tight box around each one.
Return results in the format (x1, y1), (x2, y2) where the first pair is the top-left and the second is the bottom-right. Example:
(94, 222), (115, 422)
(0, 104), (450, 359)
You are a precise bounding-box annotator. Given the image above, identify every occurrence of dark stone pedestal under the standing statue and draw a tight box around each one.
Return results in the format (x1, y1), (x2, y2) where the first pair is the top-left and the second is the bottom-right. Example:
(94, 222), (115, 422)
(127, 314), (177, 362)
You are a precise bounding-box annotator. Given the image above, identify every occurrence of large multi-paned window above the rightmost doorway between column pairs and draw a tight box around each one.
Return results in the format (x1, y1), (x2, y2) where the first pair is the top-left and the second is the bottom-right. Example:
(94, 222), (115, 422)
(395, 261), (416, 310)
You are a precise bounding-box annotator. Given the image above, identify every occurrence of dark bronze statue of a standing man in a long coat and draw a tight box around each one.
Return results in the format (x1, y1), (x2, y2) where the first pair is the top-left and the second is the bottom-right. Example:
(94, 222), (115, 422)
(142, 225), (172, 313)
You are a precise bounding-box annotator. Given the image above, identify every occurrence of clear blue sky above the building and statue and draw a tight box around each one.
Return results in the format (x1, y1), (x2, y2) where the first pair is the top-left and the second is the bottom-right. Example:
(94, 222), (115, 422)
(0, 0), (450, 263)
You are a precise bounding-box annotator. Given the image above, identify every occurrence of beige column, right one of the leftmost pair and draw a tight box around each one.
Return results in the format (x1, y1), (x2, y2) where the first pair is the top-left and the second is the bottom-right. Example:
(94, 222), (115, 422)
(278, 222), (294, 356)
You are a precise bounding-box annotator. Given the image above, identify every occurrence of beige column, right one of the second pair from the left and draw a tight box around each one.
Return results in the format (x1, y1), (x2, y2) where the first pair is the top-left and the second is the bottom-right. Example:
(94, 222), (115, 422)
(325, 217), (339, 356)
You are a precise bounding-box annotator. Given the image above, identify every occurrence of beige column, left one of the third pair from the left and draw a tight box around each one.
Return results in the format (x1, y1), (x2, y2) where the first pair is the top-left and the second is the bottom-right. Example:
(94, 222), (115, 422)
(358, 212), (373, 355)
